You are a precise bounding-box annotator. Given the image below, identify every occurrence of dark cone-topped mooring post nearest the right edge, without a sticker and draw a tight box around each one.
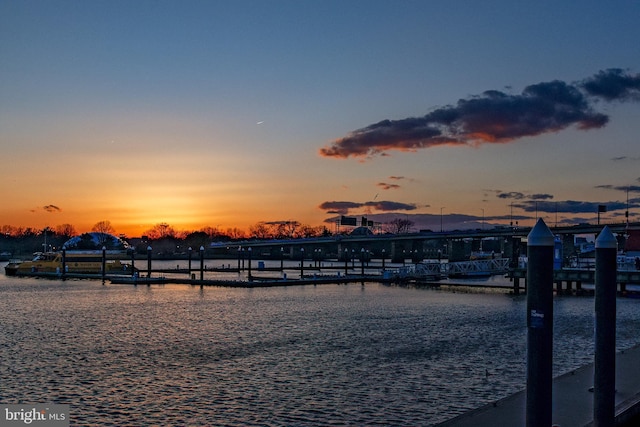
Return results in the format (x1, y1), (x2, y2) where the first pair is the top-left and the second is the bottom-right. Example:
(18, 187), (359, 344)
(593, 226), (618, 427)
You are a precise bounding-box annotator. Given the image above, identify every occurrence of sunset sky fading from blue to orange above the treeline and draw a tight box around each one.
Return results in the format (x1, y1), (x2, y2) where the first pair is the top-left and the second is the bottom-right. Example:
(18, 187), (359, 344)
(0, 0), (640, 236)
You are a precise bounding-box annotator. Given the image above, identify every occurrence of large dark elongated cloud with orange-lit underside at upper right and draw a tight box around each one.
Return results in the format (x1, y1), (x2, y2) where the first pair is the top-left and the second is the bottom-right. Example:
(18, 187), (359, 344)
(320, 69), (640, 158)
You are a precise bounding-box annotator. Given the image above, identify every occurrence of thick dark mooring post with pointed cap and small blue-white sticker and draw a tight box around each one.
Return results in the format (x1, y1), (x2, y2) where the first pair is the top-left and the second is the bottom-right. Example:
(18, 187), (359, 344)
(526, 218), (554, 427)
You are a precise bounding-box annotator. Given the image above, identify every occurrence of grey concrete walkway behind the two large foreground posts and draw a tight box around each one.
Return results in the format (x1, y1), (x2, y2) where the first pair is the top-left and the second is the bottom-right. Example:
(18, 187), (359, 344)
(438, 346), (640, 427)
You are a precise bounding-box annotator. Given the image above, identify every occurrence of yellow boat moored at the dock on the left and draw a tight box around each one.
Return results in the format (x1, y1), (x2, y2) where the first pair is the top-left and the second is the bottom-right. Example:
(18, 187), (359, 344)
(4, 251), (132, 276)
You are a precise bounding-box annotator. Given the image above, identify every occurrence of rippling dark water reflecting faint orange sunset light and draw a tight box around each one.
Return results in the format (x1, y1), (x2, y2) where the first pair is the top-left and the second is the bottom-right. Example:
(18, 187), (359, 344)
(0, 262), (640, 426)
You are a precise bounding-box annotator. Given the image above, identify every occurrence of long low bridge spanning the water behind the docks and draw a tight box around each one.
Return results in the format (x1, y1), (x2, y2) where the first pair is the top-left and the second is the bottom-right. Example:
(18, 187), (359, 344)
(207, 222), (640, 262)
